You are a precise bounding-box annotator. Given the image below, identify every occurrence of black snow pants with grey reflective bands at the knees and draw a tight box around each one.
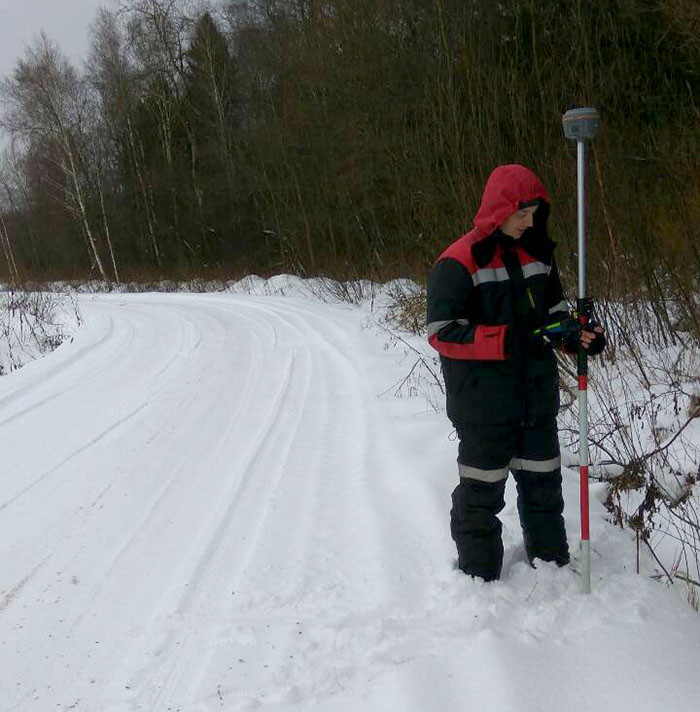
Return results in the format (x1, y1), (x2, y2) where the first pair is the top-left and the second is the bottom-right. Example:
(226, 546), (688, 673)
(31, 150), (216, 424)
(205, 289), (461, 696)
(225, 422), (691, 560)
(450, 417), (569, 581)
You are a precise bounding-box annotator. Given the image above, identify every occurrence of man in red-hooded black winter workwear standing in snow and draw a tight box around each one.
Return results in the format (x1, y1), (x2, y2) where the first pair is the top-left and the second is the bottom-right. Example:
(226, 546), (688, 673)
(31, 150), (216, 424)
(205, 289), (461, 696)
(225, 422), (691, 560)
(427, 164), (605, 581)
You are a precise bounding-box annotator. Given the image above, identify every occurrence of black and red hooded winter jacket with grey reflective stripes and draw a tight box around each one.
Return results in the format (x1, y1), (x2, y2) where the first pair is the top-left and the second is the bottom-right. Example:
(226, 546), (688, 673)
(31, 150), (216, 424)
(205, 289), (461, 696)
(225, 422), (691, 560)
(428, 165), (567, 428)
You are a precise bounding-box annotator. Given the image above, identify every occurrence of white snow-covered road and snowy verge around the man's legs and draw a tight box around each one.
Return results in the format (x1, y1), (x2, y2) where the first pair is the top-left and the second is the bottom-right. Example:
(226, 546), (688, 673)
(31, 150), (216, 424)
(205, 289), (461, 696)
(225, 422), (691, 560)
(0, 286), (700, 712)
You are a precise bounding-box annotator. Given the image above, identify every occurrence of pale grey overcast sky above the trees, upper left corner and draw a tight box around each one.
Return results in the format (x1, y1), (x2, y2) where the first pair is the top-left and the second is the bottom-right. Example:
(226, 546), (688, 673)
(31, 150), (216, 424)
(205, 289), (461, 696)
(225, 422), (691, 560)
(0, 0), (116, 78)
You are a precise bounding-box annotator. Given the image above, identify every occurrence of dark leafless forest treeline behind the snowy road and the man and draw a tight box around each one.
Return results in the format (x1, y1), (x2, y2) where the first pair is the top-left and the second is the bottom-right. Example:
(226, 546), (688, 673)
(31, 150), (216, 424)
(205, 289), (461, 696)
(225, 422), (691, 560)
(0, 0), (700, 318)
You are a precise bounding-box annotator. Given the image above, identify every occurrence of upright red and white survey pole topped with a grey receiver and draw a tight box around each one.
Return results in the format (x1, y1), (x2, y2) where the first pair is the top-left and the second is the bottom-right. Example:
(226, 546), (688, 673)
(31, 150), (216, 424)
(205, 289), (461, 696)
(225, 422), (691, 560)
(562, 108), (600, 593)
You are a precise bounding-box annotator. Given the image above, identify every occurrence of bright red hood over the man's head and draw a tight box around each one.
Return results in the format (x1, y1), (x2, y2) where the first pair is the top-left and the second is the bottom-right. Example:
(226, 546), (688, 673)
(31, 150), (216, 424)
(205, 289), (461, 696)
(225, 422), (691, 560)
(474, 163), (549, 236)
